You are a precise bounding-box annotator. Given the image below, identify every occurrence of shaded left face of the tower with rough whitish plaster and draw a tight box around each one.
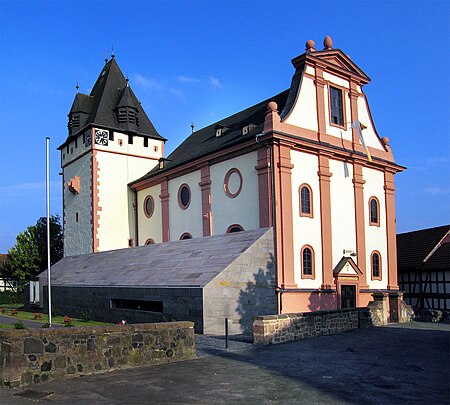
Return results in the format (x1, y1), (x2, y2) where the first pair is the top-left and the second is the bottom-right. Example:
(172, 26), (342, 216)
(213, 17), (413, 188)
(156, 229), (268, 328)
(63, 153), (92, 256)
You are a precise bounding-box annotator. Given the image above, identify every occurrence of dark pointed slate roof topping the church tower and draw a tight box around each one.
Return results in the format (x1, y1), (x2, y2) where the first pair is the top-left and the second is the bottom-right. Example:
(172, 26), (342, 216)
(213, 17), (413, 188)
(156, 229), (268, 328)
(58, 58), (166, 149)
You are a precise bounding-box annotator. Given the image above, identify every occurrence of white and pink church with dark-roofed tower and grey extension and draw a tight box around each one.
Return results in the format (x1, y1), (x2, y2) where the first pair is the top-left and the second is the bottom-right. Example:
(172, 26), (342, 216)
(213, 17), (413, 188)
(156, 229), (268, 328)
(41, 36), (404, 333)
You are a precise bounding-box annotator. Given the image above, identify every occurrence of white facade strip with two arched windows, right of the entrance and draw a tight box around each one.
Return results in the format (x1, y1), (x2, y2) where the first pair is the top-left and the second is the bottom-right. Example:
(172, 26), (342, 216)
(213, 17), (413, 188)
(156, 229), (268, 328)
(363, 167), (388, 289)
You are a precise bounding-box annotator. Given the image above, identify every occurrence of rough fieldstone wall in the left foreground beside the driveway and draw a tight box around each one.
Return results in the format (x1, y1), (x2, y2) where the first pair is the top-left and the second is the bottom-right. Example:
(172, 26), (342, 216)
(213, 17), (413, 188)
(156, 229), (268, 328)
(0, 322), (196, 387)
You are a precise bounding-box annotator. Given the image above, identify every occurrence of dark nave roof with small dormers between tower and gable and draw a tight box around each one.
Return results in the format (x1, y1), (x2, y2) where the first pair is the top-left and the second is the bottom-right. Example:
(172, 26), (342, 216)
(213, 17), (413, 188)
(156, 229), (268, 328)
(131, 89), (289, 184)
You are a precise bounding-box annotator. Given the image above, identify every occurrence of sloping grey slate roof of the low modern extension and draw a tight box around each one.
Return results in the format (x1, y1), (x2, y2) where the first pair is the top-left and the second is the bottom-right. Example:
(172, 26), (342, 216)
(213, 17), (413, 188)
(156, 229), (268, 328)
(39, 228), (268, 288)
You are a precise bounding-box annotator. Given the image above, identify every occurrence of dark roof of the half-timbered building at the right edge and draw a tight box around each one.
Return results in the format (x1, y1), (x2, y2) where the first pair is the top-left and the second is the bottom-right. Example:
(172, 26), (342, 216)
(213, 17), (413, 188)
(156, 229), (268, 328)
(397, 225), (450, 271)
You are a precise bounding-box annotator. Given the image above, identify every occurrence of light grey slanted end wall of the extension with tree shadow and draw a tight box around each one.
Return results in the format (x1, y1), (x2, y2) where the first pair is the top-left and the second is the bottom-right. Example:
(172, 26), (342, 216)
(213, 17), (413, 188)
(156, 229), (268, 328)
(203, 229), (277, 335)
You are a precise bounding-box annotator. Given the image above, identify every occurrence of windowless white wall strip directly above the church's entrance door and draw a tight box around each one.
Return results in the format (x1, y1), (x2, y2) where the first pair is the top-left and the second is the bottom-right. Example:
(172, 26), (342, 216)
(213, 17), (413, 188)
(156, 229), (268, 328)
(330, 159), (358, 268)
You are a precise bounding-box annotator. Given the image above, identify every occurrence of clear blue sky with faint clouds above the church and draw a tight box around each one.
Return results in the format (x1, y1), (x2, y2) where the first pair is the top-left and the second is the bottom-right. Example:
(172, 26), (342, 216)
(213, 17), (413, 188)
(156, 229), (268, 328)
(0, 0), (450, 253)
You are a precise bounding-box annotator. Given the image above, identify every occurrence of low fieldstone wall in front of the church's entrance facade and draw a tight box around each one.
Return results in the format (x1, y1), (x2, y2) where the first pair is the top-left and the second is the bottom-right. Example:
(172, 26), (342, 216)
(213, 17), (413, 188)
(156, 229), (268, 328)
(253, 308), (372, 344)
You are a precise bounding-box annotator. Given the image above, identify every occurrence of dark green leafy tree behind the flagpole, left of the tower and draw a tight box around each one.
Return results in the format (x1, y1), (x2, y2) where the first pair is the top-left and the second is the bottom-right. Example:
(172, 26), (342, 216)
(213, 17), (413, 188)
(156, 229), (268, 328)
(6, 215), (63, 283)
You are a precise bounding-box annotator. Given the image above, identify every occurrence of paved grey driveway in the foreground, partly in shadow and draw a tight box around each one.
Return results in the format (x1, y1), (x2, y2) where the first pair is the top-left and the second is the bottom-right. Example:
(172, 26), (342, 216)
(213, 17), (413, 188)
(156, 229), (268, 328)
(0, 323), (450, 404)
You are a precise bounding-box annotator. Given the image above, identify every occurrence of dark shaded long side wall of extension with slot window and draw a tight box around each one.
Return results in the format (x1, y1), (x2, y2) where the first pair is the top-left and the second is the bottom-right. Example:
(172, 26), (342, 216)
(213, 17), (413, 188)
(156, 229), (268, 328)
(41, 286), (203, 333)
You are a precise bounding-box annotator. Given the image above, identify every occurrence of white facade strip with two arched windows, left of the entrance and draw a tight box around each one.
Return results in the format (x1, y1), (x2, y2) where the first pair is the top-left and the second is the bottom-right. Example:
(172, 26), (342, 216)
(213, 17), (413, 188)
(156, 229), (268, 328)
(291, 151), (322, 288)
